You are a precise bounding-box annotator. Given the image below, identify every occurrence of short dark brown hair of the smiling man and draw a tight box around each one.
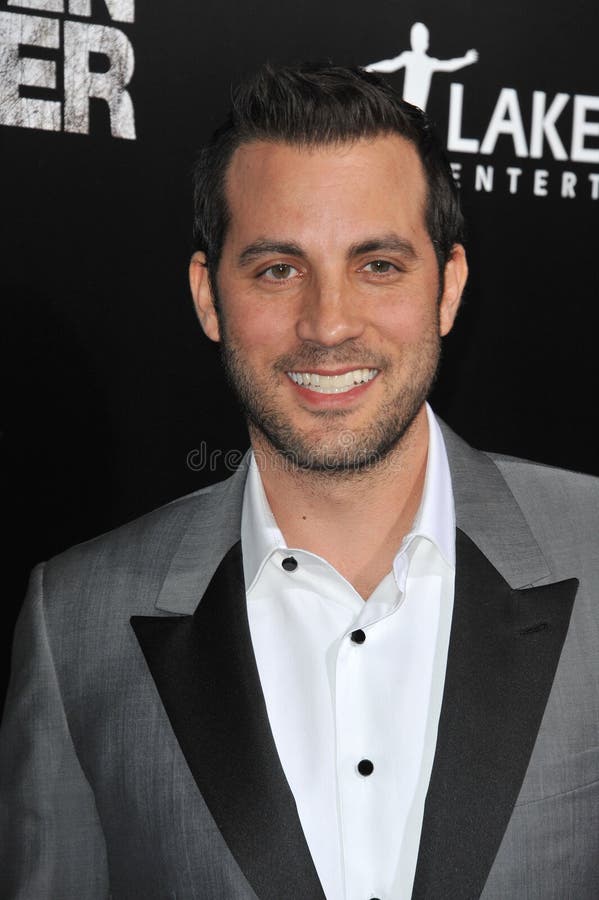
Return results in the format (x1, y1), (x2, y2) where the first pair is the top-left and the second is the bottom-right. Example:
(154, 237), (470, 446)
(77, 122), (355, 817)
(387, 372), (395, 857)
(193, 63), (463, 278)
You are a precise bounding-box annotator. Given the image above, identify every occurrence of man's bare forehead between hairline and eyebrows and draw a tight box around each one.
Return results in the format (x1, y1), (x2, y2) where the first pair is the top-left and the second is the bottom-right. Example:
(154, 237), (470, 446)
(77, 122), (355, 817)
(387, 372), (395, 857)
(226, 134), (426, 239)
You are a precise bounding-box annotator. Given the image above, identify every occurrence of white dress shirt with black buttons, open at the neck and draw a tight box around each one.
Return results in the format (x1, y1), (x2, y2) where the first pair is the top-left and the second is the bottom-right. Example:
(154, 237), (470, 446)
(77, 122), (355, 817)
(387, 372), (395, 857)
(241, 405), (455, 900)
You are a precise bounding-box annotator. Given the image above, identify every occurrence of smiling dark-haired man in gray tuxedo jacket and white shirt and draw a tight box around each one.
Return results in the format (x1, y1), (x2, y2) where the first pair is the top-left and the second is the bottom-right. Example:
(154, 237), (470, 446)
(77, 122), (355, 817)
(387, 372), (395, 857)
(0, 67), (599, 900)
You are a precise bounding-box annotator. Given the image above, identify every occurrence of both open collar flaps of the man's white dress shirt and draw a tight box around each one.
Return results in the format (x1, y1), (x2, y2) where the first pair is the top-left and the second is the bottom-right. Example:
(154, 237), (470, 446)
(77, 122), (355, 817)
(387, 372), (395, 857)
(241, 403), (455, 591)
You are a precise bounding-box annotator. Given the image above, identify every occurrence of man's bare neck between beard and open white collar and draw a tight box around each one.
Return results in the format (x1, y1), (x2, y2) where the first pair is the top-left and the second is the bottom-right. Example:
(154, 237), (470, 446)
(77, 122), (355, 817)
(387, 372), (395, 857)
(252, 407), (428, 599)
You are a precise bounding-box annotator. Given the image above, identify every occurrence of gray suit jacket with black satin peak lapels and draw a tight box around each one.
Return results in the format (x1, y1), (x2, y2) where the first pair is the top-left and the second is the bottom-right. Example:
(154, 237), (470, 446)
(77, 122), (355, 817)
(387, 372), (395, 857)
(0, 429), (599, 900)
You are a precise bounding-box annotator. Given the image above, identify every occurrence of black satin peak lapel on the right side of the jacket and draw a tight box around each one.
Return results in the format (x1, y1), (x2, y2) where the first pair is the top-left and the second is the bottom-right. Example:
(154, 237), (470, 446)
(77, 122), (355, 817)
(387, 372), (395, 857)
(412, 530), (578, 900)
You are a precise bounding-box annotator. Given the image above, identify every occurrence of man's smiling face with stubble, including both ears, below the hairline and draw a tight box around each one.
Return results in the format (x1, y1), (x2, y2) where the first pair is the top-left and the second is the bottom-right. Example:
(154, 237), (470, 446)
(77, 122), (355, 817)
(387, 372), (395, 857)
(191, 136), (466, 471)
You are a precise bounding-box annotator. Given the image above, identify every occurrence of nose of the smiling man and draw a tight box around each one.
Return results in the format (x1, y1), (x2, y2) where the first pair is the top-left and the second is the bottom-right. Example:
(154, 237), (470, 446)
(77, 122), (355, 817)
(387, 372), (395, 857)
(296, 279), (365, 347)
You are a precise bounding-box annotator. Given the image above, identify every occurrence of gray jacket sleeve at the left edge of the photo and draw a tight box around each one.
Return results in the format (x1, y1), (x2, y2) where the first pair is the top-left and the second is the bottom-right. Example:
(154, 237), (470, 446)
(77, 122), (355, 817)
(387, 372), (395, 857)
(0, 566), (109, 900)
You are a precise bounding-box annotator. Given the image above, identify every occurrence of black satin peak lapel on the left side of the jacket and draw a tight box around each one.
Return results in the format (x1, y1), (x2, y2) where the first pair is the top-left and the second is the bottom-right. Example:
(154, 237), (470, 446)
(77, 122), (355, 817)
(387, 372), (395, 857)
(131, 542), (324, 900)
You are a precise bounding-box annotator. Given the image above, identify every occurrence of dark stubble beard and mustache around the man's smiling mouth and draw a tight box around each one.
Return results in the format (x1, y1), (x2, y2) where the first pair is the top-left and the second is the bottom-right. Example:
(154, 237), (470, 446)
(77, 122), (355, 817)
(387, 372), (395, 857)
(219, 315), (441, 476)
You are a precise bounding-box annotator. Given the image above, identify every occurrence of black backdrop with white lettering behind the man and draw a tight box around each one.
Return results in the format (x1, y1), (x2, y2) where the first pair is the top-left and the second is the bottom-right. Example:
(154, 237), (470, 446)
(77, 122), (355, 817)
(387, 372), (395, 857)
(0, 0), (599, 708)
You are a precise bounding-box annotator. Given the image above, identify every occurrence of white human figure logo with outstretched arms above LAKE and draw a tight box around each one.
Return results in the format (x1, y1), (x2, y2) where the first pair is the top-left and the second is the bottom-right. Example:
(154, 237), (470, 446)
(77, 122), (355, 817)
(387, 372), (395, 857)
(365, 22), (478, 110)
